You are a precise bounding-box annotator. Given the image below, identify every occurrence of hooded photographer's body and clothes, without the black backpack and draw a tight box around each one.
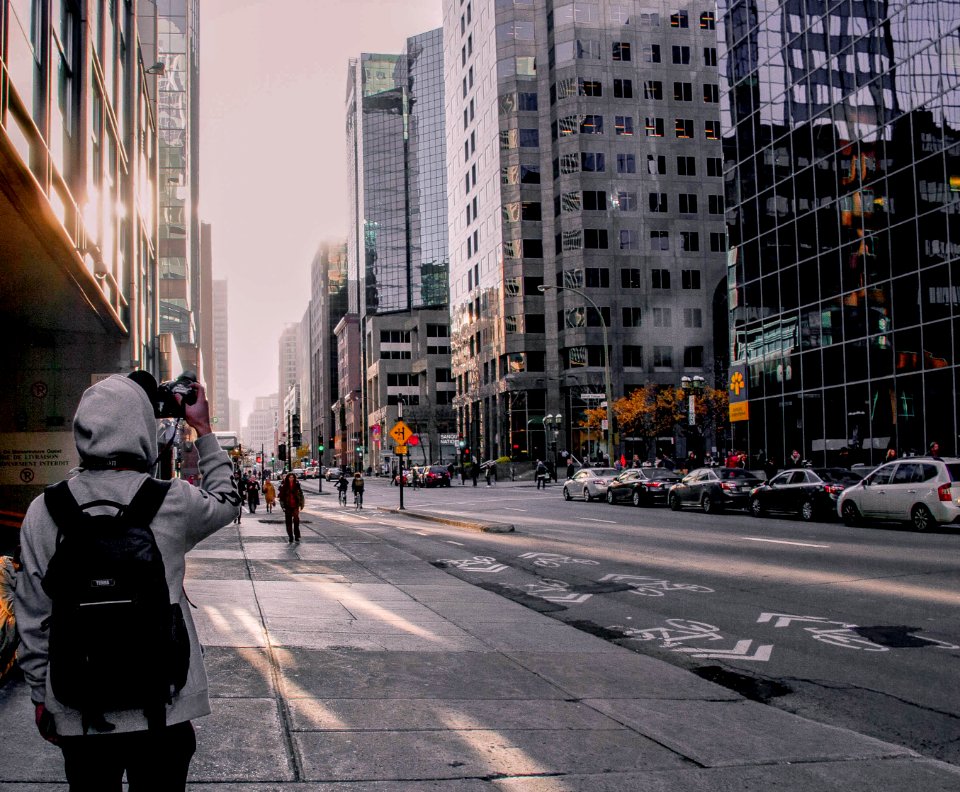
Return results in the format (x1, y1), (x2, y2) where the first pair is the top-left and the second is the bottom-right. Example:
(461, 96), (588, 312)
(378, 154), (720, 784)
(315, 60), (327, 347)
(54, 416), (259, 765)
(15, 372), (240, 792)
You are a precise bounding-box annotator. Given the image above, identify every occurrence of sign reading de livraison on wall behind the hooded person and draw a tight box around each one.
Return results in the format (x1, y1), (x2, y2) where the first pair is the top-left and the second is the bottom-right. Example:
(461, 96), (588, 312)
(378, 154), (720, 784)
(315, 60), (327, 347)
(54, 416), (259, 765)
(0, 432), (80, 487)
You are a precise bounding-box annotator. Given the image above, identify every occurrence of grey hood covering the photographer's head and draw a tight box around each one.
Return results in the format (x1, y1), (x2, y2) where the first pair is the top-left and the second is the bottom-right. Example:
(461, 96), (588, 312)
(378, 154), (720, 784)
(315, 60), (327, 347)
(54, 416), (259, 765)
(73, 374), (157, 464)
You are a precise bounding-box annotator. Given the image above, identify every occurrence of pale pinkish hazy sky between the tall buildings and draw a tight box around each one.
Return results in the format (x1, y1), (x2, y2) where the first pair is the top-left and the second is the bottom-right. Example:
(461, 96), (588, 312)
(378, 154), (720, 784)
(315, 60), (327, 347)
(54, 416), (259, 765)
(200, 0), (442, 423)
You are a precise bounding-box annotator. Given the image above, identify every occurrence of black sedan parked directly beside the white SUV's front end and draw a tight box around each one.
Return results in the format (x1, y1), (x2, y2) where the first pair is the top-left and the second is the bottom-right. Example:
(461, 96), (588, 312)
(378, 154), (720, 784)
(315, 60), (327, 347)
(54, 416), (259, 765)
(750, 468), (863, 521)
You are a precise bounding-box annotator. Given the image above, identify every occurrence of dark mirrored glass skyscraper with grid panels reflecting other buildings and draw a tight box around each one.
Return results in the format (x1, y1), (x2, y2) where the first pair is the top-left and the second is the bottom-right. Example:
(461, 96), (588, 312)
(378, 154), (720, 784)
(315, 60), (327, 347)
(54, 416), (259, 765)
(719, 0), (960, 464)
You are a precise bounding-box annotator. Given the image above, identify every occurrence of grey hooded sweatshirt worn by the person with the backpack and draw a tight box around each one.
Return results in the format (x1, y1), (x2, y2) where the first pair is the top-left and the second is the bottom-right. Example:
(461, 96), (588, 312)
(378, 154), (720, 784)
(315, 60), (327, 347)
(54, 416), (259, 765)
(15, 375), (240, 735)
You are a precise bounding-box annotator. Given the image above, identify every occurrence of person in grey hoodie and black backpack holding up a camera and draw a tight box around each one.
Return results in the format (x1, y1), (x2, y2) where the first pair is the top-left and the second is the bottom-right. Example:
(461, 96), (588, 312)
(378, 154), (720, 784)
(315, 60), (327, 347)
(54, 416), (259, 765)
(15, 372), (242, 792)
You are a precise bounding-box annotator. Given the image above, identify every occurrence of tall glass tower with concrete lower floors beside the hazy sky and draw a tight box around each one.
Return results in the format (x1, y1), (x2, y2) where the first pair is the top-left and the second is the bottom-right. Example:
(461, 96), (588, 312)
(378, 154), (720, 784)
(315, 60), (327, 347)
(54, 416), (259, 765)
(339, 29), (455, 470)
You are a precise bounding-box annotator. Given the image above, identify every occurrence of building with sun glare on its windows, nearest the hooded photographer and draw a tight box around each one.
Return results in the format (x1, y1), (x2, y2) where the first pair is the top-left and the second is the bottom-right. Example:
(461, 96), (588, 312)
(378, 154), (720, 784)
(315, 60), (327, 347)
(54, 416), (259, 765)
(0, 0), (162, 528)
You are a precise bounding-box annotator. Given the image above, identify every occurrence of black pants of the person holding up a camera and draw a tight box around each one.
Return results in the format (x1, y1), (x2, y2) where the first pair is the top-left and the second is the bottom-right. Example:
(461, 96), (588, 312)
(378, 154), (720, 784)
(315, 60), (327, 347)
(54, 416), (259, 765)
(59, 721), (197, 792)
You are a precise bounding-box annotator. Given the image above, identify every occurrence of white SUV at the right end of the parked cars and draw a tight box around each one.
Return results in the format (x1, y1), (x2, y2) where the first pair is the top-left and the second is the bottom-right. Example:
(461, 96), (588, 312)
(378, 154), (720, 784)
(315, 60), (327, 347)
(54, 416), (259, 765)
(837, 457), (960, 531)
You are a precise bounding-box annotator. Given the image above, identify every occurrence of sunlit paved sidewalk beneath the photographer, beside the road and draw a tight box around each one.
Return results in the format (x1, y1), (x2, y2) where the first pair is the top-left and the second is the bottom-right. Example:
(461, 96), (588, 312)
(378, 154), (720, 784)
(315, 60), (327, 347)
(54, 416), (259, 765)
(0, 499), (960, 792)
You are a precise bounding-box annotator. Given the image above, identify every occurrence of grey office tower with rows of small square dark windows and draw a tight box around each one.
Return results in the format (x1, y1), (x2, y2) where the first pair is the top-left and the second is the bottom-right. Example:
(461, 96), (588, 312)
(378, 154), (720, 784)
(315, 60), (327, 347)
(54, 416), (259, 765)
(444, 0), (726, 460)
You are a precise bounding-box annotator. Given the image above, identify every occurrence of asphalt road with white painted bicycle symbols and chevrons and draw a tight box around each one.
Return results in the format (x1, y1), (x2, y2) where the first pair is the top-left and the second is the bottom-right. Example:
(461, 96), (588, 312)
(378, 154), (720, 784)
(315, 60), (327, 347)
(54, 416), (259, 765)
(306, 481), (960, 765)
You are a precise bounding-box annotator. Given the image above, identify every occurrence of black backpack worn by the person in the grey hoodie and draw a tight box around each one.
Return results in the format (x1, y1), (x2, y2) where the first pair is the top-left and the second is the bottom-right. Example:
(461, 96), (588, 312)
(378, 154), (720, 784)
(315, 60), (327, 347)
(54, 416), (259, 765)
(42, 478), (190, 733)
